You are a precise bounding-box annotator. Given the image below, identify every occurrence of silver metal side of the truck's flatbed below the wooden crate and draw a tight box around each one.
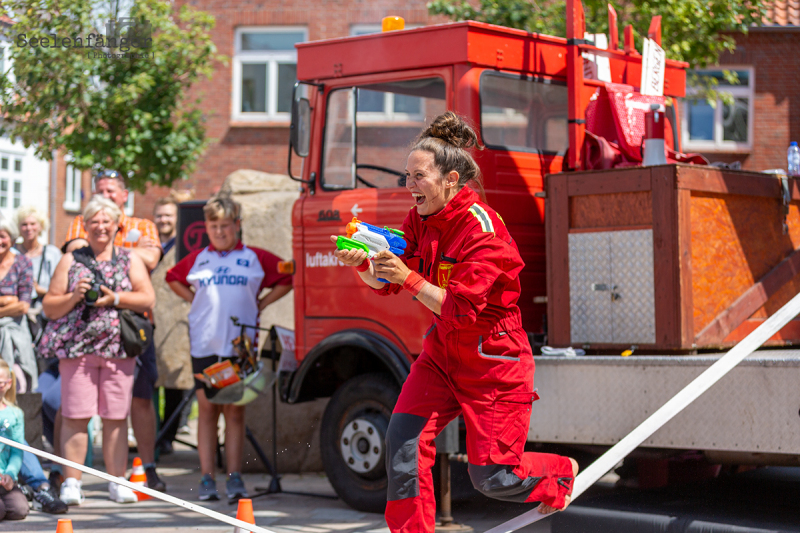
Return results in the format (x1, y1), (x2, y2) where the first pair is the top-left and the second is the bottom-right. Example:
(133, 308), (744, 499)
(528, 349), (800, 466)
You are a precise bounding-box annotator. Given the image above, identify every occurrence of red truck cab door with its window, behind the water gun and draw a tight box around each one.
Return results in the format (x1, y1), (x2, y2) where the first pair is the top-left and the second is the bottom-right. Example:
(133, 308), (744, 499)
(303, 69), (451, 356)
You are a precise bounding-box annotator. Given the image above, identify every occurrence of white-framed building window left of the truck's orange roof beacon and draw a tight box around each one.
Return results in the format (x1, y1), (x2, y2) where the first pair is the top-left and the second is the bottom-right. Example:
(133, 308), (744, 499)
(233, 27), (307, 121)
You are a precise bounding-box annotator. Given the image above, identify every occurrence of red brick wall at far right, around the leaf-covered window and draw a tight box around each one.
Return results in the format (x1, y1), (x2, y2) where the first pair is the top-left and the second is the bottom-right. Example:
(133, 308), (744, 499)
(704, 29), (800, 171)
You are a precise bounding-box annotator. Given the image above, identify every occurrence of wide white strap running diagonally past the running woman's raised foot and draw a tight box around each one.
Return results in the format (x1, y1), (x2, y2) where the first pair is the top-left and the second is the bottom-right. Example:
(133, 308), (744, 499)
(486, 294), (800, 533)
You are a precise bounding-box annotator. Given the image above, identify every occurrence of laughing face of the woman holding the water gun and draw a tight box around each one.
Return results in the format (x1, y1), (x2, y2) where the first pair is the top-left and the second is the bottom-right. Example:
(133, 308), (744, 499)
(406, 150), (458, 215)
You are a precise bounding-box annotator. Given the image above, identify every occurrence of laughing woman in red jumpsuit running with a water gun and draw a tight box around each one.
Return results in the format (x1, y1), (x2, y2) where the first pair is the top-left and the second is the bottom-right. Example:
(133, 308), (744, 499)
(332, 112), (578, 533)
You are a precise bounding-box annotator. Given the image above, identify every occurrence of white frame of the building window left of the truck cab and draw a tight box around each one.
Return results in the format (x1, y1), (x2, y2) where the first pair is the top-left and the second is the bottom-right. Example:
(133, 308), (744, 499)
(231, 26), (308, 123)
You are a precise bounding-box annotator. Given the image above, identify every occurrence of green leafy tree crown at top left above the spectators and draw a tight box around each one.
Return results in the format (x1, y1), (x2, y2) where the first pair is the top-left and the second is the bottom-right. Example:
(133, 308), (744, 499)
(0, 0), (223, 191)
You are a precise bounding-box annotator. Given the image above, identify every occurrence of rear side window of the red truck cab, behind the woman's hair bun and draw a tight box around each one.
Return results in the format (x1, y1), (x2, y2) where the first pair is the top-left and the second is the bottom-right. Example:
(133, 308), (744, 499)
(481, 72), (569, 155)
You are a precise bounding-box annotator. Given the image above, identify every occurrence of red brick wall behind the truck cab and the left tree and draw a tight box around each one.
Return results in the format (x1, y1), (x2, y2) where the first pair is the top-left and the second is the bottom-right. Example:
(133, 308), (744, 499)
(54, 0), (444, 224)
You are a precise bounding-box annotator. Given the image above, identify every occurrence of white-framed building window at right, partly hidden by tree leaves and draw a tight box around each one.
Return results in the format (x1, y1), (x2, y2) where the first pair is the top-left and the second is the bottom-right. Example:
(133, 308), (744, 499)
(683, 67), (755, 151)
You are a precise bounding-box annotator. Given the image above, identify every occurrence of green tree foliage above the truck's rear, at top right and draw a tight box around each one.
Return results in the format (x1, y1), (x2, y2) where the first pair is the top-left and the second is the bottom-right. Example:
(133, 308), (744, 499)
(428, 0), (766, 68)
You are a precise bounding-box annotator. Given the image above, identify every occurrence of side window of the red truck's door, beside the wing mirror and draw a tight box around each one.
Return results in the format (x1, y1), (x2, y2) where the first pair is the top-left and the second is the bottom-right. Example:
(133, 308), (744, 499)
(321, 78), (447, 189)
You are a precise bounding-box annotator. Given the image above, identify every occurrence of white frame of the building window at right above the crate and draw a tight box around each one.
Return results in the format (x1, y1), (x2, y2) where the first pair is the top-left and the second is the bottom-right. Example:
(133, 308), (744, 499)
(681, 65), (756, 152)
